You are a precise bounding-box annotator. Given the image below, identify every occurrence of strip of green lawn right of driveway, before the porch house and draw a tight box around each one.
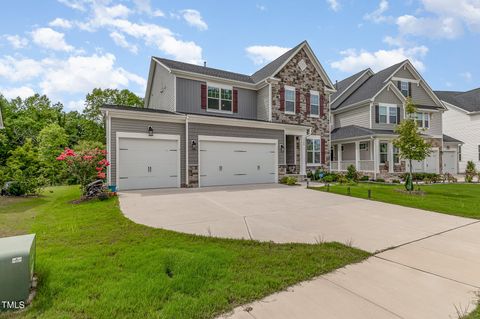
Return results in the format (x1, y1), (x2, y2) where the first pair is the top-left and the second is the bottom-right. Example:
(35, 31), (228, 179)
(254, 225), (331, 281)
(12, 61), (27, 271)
(314, 183), (480, 219)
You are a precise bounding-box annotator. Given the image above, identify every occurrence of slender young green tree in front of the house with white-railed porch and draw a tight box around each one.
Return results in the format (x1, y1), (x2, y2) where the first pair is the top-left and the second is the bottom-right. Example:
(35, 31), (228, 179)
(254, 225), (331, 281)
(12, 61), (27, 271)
(393, 98), (431, 191)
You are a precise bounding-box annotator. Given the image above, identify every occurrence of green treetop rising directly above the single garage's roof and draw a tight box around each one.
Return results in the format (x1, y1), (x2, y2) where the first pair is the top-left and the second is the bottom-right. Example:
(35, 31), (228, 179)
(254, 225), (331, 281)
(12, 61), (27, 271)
(83, 88), (143, 124)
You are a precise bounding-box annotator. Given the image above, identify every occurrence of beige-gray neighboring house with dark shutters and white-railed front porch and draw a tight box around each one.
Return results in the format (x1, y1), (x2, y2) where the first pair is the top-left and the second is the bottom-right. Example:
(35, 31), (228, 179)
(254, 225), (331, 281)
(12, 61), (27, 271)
(331, 60), (460, 178)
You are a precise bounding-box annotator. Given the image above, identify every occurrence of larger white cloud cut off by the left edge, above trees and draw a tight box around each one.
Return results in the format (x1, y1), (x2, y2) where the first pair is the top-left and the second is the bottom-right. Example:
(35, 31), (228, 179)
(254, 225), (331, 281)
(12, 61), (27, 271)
(0, 56), (43, 82)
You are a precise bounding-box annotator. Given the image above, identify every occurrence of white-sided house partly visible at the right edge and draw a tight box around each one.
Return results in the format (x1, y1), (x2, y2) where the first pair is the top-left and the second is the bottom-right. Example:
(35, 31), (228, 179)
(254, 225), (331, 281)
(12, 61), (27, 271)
(435, 88), (480, 173)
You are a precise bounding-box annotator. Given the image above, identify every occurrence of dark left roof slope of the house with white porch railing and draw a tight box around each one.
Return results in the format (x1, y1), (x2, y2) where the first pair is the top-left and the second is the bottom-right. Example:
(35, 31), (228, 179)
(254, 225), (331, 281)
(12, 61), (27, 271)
(332, 61), (405, 110)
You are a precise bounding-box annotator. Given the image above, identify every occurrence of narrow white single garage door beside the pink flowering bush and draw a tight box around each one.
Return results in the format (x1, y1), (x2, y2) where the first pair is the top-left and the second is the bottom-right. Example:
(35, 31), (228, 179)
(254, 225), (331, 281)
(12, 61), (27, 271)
(117, 138), (180, 190)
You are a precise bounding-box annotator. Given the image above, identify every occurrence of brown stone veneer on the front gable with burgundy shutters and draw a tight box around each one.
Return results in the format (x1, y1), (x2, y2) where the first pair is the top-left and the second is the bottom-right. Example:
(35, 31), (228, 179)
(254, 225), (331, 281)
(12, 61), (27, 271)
(272, 49), (330, 172)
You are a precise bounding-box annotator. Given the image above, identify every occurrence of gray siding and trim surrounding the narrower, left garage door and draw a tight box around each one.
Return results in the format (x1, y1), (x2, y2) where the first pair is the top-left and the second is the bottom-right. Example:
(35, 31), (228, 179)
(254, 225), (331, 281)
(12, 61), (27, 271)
(110, 118), (185, 188)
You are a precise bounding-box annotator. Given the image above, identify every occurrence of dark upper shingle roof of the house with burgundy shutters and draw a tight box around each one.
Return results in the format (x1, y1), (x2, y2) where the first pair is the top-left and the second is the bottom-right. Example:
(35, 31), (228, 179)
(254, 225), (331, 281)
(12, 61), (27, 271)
(152, 41), (333, 90)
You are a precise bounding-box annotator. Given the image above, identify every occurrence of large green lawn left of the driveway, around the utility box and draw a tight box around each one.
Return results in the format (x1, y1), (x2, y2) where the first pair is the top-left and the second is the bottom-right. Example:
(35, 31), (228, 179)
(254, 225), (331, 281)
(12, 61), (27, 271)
(0, 187), (369, 318)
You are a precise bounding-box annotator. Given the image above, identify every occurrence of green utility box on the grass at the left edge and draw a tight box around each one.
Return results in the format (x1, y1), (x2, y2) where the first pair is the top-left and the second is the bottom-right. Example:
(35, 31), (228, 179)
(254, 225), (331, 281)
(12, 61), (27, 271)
(0, 234), (35, 309)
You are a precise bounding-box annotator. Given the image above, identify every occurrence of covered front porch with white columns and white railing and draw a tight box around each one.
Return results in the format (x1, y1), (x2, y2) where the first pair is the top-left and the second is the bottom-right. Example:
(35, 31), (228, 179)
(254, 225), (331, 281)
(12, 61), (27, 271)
(330, 138), (405, 177)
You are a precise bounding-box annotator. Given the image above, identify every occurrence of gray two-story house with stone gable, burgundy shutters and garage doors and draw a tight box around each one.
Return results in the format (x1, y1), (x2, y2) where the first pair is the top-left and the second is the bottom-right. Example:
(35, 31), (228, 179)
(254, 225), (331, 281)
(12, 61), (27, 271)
(102, 41), (334, 190)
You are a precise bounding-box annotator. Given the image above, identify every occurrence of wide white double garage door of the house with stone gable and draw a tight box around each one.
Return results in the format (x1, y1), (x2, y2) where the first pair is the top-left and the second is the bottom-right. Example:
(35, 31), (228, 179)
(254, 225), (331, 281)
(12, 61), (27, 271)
(199, 140), (278, 186)
